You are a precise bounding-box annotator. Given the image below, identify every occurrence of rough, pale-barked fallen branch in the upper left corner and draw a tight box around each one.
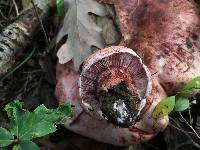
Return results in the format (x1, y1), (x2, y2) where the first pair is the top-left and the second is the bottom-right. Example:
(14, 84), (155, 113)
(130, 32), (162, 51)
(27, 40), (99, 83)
(0, 0), (54, 75)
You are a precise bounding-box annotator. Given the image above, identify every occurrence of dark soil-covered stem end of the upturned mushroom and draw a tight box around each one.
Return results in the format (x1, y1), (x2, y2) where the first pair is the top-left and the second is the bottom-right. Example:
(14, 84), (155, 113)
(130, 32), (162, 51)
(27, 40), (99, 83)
(98, 81), (140, 128)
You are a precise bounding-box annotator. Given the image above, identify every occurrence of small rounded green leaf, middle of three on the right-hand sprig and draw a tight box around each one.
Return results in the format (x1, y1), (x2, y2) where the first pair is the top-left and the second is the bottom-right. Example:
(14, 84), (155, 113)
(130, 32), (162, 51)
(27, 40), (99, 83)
(173, 97), (190, 112)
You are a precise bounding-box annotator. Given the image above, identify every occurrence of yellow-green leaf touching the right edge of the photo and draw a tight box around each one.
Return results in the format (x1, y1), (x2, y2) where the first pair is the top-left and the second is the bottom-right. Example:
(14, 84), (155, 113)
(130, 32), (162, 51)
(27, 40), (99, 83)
(180, 76), (200, 97)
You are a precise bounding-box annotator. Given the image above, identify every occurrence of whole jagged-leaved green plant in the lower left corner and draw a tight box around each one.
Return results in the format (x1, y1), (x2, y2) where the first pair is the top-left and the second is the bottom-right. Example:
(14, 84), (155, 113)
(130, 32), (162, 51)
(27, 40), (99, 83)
(0, 100), (73, 150)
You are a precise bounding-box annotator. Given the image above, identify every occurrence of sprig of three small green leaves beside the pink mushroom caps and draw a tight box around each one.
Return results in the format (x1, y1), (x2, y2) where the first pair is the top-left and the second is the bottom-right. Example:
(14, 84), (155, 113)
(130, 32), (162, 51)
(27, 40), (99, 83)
(152, 77), (200, 119)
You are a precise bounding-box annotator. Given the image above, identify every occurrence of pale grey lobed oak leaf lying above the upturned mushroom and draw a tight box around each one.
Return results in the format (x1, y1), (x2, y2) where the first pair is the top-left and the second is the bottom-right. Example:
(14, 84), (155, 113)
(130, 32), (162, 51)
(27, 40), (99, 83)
(57, 0), (106, 70)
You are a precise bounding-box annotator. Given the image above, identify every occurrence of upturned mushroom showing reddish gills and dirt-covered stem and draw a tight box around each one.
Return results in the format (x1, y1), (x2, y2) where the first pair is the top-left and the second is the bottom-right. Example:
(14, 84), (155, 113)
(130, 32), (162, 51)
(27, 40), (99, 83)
(79, 46), (151, 127)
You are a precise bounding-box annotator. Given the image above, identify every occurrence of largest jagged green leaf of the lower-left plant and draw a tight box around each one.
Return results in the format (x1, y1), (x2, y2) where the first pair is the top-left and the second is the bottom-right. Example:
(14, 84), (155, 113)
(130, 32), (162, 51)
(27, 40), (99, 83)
(5, 100), (73, 140)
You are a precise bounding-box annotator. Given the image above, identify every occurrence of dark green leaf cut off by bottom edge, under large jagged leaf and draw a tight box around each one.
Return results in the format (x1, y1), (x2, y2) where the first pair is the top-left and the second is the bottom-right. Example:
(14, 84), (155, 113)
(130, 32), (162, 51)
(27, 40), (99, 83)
(13, 141), (40, 150)
